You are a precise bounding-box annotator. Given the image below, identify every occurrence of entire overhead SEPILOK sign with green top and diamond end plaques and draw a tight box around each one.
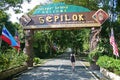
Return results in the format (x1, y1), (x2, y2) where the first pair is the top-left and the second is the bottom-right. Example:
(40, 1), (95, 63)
(20, 3), (109, 29)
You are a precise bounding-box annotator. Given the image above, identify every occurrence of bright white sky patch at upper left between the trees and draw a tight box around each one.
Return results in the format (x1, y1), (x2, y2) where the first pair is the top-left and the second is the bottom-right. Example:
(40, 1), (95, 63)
(7, 0), (47, 23)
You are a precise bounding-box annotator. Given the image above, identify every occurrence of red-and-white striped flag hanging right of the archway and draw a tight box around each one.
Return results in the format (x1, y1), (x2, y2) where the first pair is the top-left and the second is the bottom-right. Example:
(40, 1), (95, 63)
(110, 28), (119, 56)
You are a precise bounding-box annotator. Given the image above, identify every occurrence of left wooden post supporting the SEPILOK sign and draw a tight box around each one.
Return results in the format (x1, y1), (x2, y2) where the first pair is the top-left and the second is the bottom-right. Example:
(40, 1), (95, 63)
(25, 30), (34, 67)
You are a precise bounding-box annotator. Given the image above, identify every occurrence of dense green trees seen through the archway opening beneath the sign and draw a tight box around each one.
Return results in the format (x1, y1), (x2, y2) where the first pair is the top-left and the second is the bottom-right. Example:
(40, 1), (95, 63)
(33, 29), (90, 58)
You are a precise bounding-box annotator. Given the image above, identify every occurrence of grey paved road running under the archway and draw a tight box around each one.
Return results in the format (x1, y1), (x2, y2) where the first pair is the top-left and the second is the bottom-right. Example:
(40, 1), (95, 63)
(15, 59), (98, 80)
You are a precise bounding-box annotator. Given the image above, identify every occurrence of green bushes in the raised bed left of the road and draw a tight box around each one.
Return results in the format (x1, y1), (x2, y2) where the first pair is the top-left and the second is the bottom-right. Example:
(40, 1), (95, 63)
(0, 49), (27, 71)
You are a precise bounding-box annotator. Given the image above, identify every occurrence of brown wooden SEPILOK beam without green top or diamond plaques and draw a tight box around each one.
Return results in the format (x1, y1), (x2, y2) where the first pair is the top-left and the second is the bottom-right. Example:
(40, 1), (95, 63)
(19, 11), (101, 29)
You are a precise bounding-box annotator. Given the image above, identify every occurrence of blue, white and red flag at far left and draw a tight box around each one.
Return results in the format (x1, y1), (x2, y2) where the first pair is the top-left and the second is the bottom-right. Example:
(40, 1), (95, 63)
(0, 26), (18, 47)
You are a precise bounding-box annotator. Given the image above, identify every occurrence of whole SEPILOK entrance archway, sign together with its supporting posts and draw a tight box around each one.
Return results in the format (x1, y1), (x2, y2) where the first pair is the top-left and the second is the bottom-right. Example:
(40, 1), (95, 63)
(20, 3), (108, 66)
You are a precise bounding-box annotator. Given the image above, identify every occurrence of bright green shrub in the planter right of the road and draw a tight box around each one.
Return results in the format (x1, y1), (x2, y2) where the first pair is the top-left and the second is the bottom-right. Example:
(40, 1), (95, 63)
(97, 55), (120, 75)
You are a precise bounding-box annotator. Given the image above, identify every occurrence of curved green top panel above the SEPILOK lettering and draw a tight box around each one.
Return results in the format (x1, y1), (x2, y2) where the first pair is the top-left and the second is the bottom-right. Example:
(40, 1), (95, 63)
(33, 2), (90, 15)
